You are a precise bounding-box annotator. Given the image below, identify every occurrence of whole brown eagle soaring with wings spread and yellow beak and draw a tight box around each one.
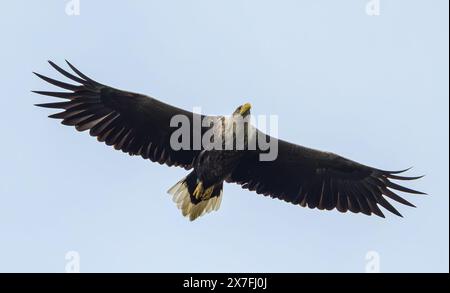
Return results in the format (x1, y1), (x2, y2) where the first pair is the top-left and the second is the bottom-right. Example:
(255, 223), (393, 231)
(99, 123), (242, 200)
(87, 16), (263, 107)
(33, 61), (425, 221)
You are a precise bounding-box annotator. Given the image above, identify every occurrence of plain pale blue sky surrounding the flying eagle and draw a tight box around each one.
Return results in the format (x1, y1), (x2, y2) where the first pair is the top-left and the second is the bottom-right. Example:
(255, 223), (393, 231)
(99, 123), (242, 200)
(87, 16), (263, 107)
(0, 0), (449, 272)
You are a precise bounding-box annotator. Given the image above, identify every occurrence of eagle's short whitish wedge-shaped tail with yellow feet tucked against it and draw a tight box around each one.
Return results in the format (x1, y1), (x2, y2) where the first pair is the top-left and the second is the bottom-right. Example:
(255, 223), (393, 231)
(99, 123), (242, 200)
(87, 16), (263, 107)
(167, 171), (223, 221)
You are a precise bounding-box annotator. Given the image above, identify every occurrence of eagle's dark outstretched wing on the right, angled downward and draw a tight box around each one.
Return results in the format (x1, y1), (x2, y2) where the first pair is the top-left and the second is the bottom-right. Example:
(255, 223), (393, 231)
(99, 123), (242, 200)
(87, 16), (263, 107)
(228, 135), (424, 217)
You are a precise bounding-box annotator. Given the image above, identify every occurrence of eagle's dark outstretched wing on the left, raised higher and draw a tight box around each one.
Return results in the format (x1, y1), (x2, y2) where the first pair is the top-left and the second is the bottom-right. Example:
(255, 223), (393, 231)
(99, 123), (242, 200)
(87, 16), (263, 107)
(34, 61), (209, 169)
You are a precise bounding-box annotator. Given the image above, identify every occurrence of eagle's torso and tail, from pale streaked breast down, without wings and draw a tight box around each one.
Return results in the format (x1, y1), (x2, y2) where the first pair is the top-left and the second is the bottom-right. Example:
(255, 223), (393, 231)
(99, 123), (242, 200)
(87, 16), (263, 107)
(169, 110), (256, 220)
